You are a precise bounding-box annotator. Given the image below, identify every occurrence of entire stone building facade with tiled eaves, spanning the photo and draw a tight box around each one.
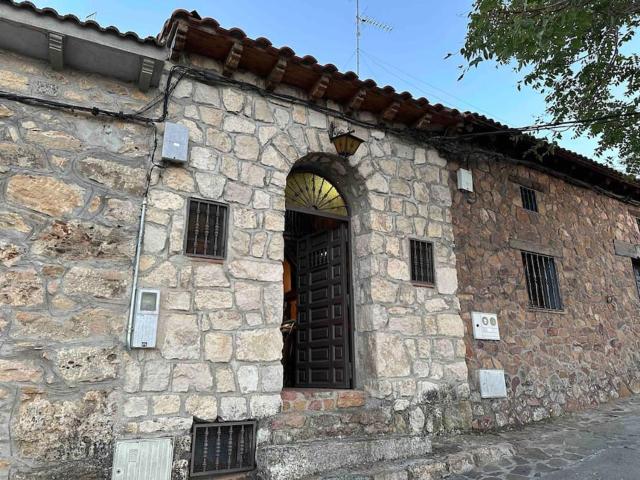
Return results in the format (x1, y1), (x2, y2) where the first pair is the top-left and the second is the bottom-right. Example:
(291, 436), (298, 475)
(0, 2), (640, 480)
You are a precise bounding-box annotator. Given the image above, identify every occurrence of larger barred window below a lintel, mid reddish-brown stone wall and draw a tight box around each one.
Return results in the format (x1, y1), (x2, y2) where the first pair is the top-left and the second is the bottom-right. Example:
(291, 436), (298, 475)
(522, 252), (563, 310)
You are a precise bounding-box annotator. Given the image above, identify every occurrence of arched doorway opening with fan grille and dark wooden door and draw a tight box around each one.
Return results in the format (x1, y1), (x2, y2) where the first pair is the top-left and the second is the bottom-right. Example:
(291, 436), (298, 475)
(282, 170), (353, 388)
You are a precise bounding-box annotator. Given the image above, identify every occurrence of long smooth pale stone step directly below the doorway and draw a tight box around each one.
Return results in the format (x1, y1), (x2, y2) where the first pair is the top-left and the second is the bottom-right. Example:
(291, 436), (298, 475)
(257, 435), (431, 480)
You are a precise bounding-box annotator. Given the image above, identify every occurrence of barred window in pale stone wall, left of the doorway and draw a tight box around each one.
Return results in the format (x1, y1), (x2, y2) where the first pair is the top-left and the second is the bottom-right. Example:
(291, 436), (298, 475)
(184, 198), (229, 259)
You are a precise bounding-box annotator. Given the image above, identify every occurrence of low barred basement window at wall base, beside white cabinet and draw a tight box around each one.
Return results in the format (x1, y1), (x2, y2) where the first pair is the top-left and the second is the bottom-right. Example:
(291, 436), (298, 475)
(190, 421), (256, 478)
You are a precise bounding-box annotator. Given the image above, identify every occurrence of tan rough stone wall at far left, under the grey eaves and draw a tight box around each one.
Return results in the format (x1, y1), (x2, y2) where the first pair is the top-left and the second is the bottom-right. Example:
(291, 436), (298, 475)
(0, 47), (152, 479)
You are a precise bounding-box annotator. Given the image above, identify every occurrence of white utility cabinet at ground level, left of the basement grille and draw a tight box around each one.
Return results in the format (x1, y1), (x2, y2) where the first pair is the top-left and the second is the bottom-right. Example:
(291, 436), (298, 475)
(111, 438), (173, 480)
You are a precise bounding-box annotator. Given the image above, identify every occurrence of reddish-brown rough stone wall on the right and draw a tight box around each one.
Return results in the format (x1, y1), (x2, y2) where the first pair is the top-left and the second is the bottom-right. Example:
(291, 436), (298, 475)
(449, 150), (640, 429)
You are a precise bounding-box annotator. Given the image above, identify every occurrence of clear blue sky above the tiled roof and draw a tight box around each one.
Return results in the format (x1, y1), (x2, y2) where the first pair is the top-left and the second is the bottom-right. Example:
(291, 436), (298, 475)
(34, 0), (596, 163)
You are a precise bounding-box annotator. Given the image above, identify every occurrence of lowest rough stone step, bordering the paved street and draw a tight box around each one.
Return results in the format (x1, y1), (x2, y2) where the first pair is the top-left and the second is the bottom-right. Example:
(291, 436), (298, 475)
(303, 436), (515, 480)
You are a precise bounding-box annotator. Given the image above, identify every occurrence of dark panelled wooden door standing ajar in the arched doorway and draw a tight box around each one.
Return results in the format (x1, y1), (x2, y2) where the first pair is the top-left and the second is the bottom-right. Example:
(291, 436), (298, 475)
(295, 225), (352, 388)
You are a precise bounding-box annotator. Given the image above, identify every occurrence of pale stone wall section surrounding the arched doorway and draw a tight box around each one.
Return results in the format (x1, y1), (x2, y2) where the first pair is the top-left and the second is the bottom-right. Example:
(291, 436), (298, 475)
(150, 52), (467, 418)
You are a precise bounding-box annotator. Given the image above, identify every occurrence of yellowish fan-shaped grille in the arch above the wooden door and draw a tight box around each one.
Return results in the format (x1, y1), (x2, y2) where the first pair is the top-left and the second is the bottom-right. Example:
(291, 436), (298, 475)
(285, 172), (349, 217)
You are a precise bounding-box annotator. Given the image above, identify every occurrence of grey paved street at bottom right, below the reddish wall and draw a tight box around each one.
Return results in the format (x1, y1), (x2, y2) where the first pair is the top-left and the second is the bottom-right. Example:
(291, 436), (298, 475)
(447, 396), (640, 480)
